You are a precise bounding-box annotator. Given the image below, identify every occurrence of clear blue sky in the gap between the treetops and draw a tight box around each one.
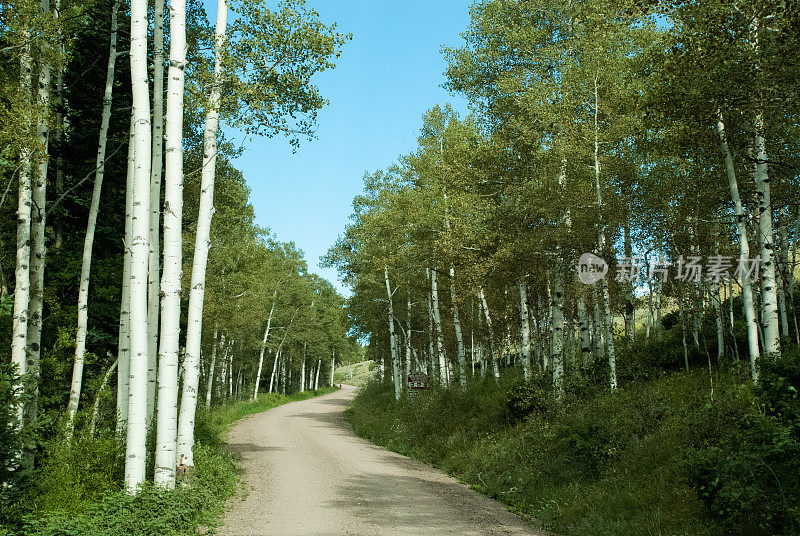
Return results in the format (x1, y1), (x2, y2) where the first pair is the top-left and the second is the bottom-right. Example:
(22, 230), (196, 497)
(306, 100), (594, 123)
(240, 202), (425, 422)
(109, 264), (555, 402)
(212, 0), (470, 289)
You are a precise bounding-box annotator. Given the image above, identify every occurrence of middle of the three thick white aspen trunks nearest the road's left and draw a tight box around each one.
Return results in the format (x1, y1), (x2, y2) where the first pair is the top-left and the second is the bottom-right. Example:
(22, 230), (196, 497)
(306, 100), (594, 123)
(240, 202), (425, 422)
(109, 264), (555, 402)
(154, 0), (186, 489)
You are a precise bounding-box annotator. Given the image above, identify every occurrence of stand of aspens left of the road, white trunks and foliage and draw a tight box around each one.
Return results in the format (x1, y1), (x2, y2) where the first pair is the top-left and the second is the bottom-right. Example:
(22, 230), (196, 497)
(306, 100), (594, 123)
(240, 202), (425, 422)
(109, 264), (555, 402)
(0, 0), (355, 516)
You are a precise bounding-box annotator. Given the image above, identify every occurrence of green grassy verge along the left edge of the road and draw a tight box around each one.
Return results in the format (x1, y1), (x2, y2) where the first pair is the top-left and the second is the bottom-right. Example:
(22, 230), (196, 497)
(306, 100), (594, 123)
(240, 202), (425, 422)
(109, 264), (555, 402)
(18, 387), (336, 536)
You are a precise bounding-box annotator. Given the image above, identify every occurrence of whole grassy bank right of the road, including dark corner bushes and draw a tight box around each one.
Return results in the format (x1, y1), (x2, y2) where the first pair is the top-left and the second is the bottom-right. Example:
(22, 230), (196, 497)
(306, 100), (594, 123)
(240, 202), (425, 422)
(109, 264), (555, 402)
(346, 364), (800, 536)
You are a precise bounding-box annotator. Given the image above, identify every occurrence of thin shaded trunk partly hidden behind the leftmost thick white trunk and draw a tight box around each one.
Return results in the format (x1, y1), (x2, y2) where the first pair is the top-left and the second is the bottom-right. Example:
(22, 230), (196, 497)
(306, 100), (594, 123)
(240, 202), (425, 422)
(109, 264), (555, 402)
(117, 114), (136, 433)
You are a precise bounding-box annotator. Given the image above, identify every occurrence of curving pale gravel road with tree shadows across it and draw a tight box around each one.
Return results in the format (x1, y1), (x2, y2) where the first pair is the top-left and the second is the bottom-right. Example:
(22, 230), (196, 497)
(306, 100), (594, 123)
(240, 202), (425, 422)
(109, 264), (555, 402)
(219, 385), (544, 536)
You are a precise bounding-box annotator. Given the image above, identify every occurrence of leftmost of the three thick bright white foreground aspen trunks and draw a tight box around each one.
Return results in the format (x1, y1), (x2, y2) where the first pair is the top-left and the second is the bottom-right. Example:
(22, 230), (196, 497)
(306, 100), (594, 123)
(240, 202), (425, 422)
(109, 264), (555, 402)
(125, 0), (151, 493)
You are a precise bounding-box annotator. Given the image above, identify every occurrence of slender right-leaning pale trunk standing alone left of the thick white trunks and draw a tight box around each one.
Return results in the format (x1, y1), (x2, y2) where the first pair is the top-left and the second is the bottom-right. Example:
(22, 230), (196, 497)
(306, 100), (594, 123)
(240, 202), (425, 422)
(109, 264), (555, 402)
(67, 0), (121, 437)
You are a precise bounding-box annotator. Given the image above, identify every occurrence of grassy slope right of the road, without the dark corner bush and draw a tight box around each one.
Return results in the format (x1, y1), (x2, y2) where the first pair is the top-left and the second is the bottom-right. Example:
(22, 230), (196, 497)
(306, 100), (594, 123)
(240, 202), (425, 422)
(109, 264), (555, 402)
(346, 370), (769, 536)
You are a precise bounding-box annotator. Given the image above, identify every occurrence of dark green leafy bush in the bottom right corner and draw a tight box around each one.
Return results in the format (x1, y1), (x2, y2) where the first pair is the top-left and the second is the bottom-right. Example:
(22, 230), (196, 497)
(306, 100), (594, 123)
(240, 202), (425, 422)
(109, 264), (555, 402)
(685, 349), (800, 536)
